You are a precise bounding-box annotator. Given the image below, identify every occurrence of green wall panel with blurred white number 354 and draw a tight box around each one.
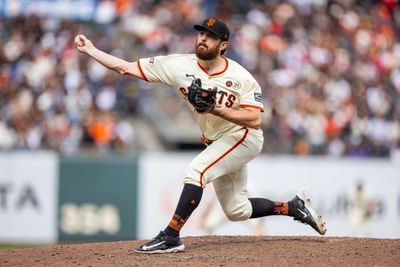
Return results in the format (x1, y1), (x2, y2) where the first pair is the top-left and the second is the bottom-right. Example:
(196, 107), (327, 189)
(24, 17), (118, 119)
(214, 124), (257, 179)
(59, 157), (137, 240)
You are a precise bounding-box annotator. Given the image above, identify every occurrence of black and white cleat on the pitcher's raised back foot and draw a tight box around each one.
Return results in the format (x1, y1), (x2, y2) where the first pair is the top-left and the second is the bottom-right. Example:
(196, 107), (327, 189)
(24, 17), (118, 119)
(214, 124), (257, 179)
(291, 192), (326, 235)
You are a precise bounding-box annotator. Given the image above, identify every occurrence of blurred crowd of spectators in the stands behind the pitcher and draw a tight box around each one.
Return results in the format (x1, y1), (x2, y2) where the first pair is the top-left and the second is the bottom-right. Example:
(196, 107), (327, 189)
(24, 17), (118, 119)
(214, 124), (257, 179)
(0, 0), (400, 157)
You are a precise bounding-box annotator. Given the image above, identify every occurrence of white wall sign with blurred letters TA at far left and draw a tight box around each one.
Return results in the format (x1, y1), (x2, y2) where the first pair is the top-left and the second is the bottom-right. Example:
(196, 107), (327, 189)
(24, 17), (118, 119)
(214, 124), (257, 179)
(0, 152), (58, 244)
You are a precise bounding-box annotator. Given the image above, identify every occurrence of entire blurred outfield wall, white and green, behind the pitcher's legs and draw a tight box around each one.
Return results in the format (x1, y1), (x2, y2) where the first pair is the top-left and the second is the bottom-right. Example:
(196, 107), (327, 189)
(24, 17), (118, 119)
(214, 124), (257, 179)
(0, 152), (400, 244)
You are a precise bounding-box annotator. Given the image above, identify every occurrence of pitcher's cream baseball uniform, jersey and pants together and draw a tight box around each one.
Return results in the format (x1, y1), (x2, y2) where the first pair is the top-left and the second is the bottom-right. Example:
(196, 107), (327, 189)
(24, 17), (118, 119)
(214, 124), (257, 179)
(138, 54), (264, 221)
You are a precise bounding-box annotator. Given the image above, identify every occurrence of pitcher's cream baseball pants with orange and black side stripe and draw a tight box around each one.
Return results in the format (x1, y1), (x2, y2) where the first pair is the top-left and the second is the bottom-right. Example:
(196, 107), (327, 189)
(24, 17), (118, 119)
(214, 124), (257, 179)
(184, 128), (264, 221)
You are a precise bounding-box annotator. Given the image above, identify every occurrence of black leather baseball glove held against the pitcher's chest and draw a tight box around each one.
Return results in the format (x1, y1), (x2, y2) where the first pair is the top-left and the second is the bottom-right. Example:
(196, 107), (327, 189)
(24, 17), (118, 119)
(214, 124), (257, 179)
(188, 78), (217, 114)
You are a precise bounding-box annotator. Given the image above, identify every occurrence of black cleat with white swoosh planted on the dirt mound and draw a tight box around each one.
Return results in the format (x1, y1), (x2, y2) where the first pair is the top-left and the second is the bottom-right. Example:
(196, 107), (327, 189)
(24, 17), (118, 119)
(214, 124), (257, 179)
(135, 231), (185, 253)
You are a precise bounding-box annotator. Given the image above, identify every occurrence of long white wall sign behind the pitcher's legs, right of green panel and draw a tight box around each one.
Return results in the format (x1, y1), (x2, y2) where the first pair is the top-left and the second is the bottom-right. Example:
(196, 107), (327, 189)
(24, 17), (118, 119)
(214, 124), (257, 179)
(139, 153), (400, 239)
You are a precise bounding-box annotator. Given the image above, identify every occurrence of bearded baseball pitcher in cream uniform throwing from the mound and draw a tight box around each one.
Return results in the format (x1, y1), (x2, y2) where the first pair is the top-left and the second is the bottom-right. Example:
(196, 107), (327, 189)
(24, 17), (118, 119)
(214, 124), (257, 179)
(75, 17), (326, 253)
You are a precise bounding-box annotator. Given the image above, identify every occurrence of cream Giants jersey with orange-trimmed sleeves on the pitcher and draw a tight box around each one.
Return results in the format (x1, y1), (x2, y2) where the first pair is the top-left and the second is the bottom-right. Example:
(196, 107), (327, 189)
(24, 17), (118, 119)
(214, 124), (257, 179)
(138, 54), (264, 140)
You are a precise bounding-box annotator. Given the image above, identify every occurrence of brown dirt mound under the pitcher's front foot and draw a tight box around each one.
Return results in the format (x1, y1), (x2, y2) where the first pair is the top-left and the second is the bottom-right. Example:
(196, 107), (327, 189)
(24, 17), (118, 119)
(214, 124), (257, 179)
(0, 236), (400, 266)
